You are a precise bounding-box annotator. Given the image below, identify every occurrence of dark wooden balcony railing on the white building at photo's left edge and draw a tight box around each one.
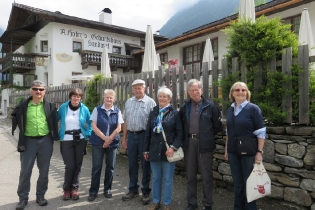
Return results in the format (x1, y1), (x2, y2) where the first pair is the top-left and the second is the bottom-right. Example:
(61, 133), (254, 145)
(0, 53), (35, 73)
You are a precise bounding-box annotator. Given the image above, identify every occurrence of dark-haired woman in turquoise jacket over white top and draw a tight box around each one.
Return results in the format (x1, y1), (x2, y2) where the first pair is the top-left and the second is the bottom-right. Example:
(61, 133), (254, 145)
(58, 88), (92, 200)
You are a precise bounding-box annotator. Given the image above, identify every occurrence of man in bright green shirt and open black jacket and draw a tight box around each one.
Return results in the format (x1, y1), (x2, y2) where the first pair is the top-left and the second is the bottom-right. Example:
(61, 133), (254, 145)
(12, 80), (59, 210)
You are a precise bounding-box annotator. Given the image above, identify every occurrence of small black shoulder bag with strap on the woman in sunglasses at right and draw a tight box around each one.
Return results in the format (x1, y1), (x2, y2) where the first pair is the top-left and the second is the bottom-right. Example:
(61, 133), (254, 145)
(232, 108), (258, 156)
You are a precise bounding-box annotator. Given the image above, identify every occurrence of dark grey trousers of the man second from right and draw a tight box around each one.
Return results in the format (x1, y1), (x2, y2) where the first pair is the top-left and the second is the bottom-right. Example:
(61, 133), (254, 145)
(185, 138), (213, 206)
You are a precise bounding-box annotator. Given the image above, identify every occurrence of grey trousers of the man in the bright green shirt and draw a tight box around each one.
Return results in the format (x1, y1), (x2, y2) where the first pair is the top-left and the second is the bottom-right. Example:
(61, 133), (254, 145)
(17, 135), (54, 200)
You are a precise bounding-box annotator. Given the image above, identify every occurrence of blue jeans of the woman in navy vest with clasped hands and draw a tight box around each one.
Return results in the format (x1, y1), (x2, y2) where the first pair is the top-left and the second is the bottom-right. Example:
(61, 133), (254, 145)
(89, 145), (117, 195)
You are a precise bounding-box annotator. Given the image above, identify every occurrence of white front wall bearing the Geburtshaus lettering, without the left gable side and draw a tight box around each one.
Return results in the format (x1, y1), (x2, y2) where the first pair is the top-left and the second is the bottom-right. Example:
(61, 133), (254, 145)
(49, 23), (144, 86)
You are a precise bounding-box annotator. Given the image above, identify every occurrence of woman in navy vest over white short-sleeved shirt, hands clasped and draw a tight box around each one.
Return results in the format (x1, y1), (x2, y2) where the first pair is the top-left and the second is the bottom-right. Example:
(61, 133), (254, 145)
(88, 89), (124, 201)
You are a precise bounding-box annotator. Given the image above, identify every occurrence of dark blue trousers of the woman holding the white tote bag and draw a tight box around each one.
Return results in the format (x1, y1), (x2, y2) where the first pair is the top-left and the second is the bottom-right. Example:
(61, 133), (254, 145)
(228, 153), (257, 210)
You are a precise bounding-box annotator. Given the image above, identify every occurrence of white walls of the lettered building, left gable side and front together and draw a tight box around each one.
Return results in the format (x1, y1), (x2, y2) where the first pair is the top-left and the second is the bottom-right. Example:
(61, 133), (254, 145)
(16, 23), (140, 86)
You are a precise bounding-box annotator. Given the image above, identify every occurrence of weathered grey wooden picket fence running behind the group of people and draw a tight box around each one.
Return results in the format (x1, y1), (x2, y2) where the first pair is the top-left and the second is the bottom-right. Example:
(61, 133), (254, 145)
(10, 45), (315, 124)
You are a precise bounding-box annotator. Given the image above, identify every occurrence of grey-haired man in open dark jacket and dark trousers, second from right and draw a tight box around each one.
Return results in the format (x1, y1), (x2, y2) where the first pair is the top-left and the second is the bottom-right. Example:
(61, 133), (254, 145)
(179, 79), (222, 210)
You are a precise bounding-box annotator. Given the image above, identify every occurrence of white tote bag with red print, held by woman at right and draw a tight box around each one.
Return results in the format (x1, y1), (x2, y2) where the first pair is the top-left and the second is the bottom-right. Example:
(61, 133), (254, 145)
(246, 162), (271, 202)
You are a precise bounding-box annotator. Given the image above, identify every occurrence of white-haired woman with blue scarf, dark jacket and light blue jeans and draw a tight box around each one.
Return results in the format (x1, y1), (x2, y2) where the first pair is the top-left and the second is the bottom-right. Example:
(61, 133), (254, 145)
(143, 87), (183, 210)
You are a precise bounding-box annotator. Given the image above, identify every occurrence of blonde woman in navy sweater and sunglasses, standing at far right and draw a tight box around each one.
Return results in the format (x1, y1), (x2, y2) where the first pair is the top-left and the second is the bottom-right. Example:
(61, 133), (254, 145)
(224, 82), (266, 210)
